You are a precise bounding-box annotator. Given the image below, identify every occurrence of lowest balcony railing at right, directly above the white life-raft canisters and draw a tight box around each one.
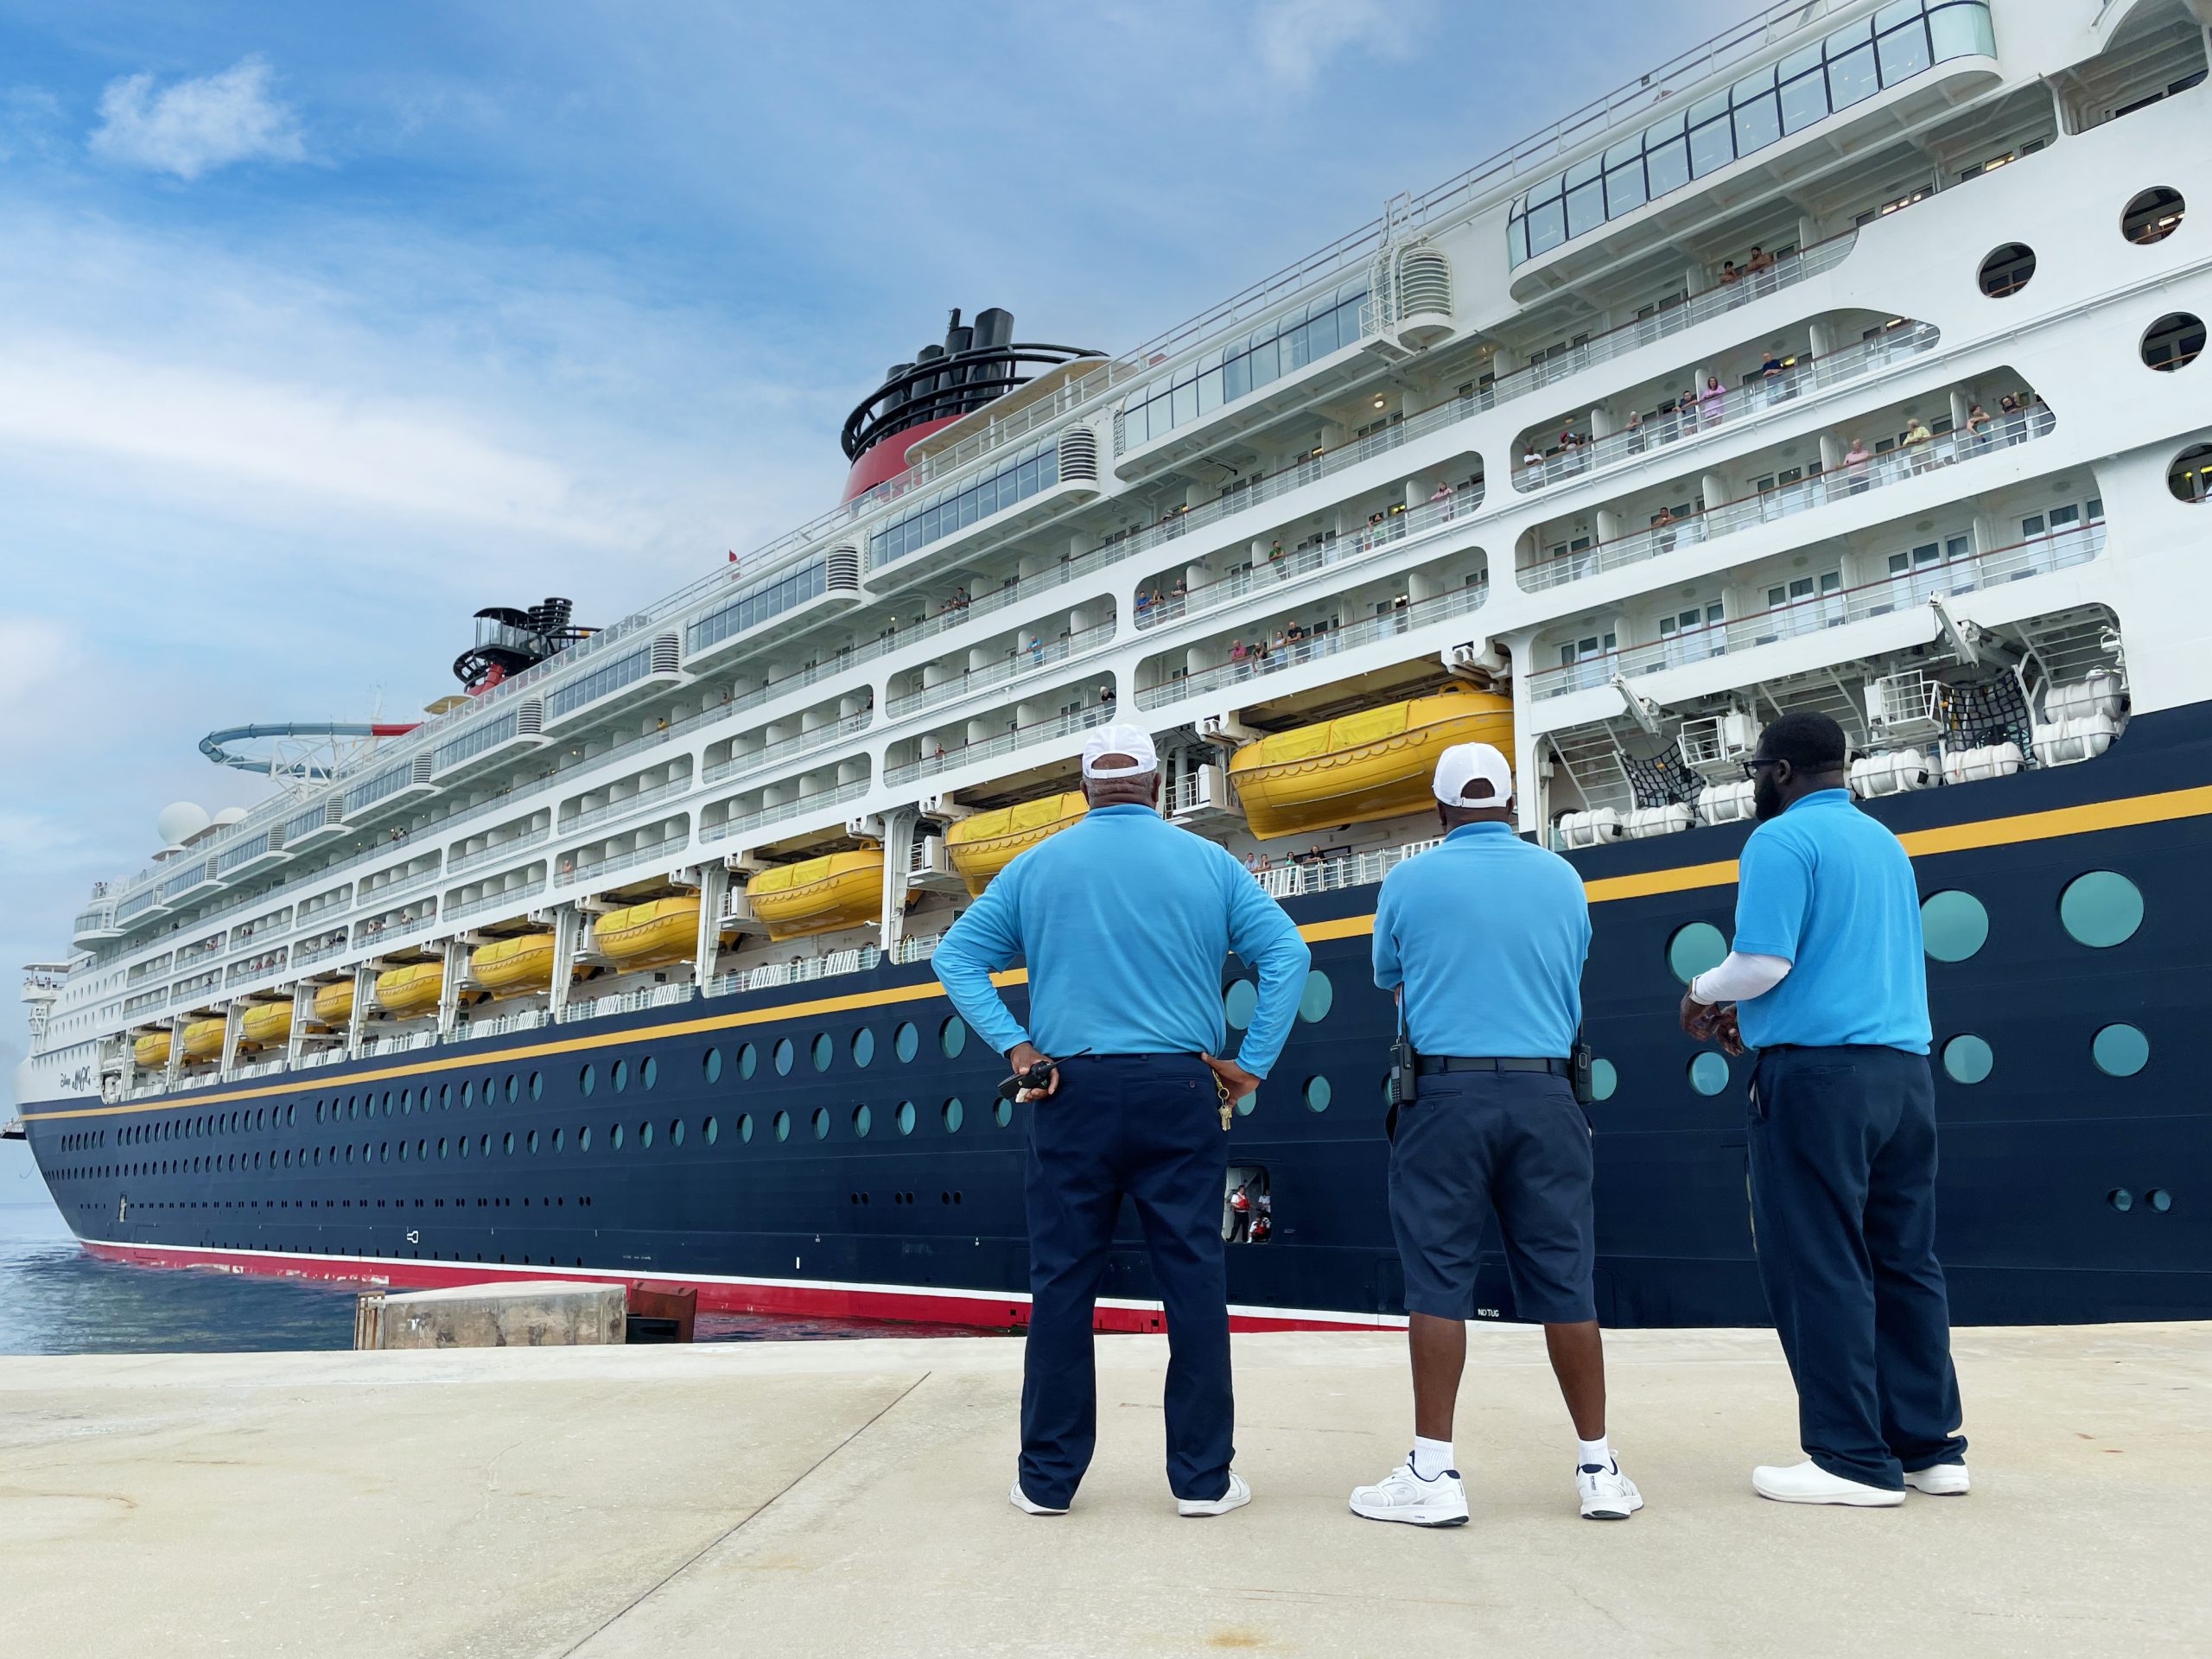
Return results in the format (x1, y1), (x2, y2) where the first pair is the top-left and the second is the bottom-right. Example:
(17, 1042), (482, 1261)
(1529, 520), (2104, 699)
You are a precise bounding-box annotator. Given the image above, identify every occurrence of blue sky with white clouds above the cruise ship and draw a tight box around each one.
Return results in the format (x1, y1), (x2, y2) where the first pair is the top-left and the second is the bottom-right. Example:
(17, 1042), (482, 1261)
(0, 0), (1738, 1065)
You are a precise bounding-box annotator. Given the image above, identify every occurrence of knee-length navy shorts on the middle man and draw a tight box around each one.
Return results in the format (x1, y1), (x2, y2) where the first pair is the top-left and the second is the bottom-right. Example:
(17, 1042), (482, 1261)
(1389, 1071), (1597, 1325)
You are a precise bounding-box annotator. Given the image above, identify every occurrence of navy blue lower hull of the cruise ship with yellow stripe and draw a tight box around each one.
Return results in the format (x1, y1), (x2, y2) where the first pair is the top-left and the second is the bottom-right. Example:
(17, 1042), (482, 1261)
(24, 708), (2212, 1327)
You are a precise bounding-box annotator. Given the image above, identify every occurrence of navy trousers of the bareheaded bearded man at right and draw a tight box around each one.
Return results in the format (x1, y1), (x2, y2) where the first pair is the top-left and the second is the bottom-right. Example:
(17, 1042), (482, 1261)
(1750, 1046), (1967, 1491)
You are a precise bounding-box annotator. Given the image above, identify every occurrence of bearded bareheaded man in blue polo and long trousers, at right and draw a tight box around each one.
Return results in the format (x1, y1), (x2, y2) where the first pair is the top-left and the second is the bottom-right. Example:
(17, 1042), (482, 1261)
(1681, 712), (1967, 1509)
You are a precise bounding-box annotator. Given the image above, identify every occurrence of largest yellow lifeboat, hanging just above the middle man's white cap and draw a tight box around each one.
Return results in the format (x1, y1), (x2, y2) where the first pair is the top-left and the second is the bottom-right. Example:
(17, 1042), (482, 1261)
(1230, 690), (1513, 838)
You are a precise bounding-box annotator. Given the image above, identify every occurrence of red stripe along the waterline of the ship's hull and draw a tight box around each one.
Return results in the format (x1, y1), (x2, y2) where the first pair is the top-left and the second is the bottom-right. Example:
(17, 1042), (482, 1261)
(79, 1239), (1405, 1332)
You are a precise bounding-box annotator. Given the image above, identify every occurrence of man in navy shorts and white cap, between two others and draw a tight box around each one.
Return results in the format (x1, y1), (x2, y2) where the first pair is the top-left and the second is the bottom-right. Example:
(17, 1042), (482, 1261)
(1351, 743), (1643, 1526)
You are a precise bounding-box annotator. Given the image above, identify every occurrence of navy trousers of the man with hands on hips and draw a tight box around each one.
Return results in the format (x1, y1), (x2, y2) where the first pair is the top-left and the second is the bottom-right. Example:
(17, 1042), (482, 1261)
(1022, 1055), (1234, 1509)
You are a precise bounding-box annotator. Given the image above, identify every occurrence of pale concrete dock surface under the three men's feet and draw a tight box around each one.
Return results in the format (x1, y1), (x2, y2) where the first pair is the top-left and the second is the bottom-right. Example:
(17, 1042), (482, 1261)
(0, 1325), (2212, 1659)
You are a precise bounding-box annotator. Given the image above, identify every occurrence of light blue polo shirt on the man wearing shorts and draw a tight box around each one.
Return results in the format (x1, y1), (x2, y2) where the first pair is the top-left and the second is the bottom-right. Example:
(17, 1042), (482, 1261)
(1374, 823), (1591, 1059)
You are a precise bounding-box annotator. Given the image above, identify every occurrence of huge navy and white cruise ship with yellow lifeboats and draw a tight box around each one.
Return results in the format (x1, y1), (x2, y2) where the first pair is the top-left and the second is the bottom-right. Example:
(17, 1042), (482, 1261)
(20, 0), (2212, 1330)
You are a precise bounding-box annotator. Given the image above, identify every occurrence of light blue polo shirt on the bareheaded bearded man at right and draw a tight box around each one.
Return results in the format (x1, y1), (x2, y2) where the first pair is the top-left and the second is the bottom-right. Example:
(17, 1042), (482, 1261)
(1734, 790), (1929, 1055)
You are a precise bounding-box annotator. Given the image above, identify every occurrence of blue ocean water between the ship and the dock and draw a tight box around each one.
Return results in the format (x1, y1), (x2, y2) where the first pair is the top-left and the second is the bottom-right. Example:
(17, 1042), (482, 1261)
(0, 1204), (995, 1354)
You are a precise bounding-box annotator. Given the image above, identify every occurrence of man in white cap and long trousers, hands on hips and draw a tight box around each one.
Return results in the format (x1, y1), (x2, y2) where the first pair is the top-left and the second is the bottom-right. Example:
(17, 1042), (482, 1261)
(931, 726), (1312, 1516)
